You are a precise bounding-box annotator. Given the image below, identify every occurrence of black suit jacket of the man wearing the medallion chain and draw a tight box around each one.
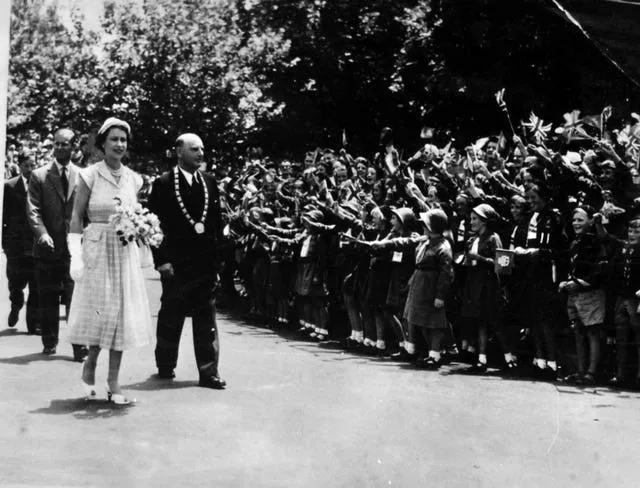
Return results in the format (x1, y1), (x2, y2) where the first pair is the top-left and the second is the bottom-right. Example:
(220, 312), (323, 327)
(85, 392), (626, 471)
(148, 170), (223, 275)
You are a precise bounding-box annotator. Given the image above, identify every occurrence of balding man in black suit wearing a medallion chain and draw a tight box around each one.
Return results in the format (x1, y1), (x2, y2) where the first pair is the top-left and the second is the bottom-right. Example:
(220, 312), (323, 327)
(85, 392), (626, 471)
(148, 134), (226, 389)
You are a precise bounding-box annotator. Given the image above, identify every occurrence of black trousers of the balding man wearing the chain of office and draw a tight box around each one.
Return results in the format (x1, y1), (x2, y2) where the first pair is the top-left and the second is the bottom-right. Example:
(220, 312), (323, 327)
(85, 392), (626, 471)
(155, 271), (220, 376)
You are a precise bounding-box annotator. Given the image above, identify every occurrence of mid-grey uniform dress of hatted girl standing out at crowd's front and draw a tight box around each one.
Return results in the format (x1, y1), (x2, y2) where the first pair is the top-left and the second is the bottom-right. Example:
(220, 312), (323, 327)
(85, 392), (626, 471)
(404, 237), (453, 329)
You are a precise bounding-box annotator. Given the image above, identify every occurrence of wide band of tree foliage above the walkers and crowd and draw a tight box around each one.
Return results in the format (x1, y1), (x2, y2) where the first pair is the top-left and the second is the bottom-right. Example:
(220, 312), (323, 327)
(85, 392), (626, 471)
(8, 0), (630, 165)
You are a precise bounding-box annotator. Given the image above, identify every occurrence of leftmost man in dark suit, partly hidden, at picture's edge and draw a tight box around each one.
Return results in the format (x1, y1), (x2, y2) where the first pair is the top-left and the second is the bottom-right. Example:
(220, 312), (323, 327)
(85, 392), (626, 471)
(2, 150), (40, 334)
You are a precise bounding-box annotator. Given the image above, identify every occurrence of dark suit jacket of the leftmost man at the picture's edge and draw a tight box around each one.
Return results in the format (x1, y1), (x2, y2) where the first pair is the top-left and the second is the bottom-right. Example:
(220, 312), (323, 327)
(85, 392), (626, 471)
(2, 176), (33, 257)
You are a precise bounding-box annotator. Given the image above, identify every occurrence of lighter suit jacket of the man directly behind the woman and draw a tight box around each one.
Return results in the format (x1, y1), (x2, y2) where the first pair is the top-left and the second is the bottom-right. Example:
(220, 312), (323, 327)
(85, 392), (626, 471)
(27, 163), (79, 259)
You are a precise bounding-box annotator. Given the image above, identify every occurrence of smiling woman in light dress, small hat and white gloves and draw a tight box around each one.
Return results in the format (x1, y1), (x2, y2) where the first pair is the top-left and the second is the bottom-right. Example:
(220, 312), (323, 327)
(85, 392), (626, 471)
(69, 117), (151, 404)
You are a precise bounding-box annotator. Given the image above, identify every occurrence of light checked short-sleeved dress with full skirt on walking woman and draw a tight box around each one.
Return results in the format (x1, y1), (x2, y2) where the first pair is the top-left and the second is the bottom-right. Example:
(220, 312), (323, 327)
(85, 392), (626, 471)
(68, 161), (151, 351)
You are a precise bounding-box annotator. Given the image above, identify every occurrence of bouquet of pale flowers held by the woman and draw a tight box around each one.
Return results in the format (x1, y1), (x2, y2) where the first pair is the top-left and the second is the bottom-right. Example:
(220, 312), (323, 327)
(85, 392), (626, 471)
(109, 197), (164, 247)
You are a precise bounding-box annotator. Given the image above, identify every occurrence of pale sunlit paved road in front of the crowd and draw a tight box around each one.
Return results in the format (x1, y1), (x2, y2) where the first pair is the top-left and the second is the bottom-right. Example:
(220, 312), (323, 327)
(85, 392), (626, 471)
(0, 264), (640, 488)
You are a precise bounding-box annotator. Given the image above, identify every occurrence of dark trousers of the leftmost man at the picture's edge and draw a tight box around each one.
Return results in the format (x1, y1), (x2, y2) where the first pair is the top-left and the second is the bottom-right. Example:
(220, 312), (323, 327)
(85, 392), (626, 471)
(7, 256), (39, 332)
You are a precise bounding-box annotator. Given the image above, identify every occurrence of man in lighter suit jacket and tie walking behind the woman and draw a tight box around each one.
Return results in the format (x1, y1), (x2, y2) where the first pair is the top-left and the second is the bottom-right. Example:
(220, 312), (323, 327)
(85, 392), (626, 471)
(27, 129), (87, 361)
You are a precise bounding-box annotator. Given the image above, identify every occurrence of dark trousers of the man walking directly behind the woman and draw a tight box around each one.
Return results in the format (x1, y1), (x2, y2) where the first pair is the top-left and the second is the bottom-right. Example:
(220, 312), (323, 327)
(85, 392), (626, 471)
(35, 258), (76, 349)
